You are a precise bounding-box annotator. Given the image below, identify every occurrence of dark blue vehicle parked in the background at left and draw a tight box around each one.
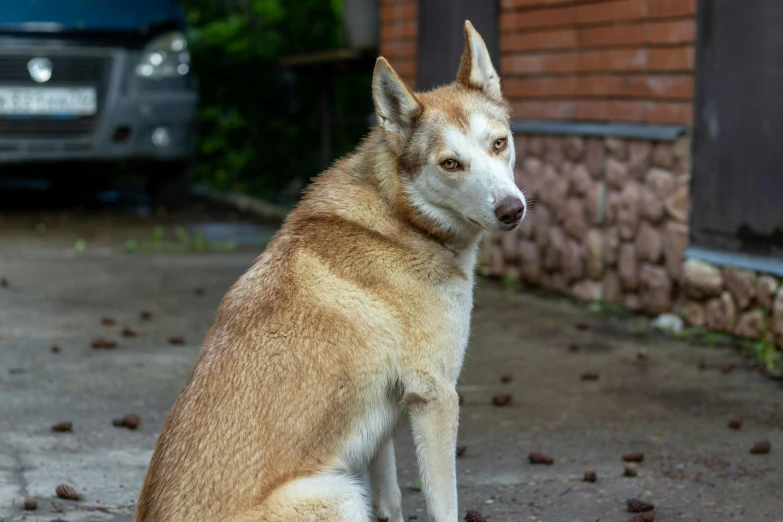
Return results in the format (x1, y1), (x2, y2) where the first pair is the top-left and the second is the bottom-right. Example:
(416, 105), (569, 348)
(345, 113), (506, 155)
(0, 0), (198, 206)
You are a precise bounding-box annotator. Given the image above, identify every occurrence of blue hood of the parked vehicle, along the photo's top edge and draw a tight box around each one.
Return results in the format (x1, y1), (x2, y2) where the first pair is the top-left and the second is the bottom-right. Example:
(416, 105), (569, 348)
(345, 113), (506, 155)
(0, 0), (182, 31)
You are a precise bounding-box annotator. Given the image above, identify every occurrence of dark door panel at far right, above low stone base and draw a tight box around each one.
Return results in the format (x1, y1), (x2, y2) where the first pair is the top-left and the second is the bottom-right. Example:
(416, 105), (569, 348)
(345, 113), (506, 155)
(691, 0), (783, 257)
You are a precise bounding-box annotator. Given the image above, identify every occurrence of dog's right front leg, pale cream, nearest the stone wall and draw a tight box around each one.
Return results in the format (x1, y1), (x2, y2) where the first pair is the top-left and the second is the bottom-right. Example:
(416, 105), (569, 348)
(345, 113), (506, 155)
(405, 379), (459, 522)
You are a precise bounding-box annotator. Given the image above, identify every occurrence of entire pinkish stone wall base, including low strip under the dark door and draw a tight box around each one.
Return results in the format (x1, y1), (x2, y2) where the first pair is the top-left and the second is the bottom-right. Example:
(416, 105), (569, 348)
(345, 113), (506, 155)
(483, 135), (783, 347)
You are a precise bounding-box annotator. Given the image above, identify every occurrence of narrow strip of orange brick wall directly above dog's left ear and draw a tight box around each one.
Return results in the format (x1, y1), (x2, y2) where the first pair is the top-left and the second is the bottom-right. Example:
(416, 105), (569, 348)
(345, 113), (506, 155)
(380, 0), (418, 88)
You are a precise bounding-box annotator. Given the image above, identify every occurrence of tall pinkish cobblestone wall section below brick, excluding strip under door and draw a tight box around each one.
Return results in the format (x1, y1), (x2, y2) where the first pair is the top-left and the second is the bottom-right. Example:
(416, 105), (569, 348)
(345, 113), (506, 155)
(489, 135), (690, 313)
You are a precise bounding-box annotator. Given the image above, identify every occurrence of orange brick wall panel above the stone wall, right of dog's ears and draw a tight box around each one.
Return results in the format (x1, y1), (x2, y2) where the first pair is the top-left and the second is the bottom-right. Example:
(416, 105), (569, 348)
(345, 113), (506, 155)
(500, 0), (696, 124)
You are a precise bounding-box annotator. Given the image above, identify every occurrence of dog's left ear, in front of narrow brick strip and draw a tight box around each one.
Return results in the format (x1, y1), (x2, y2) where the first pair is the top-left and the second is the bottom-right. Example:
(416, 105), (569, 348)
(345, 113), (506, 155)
(372, 56), (422, 140)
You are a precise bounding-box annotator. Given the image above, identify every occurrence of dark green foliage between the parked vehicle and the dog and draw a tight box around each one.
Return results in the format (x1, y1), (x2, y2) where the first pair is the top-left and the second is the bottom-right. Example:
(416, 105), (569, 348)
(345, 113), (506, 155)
(184, 0), (371, 197)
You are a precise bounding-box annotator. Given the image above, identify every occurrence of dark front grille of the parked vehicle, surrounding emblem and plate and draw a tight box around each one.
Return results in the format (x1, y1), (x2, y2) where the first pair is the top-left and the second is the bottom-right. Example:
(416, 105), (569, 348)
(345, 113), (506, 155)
(0, 52), (111, 139)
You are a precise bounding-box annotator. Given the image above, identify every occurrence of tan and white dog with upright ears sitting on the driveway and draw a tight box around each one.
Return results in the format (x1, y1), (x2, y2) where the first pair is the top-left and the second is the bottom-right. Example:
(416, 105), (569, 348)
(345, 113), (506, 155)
(134, 22), (526, 522)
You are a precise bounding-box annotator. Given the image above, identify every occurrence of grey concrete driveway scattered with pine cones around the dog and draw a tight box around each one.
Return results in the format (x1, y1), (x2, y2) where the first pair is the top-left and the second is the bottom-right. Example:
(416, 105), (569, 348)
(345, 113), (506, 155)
(0, 217), (783, 522)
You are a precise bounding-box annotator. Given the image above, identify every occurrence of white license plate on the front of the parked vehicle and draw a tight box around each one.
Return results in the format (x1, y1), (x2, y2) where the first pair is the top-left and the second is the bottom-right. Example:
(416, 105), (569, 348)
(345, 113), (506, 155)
(0, 87), (98, 116)
